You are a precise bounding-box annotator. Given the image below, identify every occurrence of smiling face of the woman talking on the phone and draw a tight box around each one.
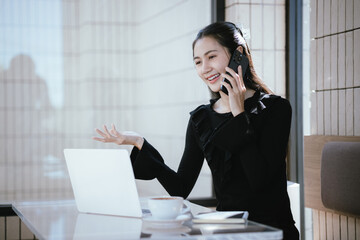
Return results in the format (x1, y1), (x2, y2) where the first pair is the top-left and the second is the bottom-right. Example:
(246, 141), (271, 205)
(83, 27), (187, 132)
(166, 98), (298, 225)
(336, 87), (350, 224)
(194, 37), (230, 92)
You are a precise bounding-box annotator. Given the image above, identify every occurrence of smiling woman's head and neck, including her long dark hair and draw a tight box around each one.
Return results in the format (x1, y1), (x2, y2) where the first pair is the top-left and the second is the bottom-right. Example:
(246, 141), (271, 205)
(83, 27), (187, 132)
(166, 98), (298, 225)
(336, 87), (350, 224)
(192, 23), (272, 113)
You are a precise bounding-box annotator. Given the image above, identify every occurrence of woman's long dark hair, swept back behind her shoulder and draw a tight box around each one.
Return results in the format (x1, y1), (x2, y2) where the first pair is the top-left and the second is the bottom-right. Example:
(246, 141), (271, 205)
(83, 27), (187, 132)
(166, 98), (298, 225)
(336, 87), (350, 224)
(192, 22), (273, 98)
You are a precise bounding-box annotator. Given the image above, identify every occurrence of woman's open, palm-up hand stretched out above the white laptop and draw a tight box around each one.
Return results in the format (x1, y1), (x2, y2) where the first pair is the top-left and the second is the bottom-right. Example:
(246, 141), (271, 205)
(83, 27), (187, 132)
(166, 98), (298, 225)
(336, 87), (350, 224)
(93, 124), (144, 150)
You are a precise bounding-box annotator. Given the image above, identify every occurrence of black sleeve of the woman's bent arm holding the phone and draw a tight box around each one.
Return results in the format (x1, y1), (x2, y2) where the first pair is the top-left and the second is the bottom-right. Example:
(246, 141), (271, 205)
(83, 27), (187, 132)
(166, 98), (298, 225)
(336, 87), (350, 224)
(214, 98), (292, 188)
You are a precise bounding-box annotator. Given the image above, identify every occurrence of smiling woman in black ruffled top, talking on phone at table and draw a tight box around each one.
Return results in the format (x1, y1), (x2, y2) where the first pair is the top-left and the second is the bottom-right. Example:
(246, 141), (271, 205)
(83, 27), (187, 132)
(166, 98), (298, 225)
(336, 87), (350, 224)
(94, 22), (299, 239)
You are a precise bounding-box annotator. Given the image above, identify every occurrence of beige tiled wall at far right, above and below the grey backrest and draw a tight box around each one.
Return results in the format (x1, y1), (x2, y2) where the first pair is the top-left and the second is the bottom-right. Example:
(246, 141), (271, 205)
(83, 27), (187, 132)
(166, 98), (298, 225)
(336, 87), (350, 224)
(310, 0), (360, 239)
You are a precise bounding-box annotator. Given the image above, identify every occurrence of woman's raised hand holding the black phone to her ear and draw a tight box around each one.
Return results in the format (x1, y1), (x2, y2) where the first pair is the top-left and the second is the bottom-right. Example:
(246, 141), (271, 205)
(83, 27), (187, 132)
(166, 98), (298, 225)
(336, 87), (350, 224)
(222, 63), (246, 117)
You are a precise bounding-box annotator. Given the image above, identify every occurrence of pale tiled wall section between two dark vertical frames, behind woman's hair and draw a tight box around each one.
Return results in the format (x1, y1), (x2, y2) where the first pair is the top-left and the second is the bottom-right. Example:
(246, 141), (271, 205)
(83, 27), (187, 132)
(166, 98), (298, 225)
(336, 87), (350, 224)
(225, 0), (286, 97)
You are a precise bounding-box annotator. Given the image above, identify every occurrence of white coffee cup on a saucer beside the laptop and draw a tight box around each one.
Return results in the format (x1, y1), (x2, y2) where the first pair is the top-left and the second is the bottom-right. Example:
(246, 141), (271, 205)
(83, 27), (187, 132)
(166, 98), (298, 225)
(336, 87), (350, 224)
(148, 196), (184, 219)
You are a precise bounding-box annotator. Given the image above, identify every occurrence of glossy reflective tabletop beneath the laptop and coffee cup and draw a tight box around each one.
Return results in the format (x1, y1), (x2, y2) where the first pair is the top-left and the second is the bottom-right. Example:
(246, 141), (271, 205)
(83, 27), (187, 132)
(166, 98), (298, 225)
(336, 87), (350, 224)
(12, 199), (282, 240)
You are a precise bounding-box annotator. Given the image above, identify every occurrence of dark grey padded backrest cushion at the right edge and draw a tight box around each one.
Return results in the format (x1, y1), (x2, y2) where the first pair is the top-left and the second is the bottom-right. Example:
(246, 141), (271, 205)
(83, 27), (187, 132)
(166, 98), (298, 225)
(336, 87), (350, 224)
(321, 142), (360, 216)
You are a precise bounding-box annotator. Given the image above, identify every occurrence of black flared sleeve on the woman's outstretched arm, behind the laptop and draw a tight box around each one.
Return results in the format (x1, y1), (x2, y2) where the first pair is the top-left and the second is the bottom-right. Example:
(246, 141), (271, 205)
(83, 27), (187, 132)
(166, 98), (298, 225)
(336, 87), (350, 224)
(131, 118), (204, 198)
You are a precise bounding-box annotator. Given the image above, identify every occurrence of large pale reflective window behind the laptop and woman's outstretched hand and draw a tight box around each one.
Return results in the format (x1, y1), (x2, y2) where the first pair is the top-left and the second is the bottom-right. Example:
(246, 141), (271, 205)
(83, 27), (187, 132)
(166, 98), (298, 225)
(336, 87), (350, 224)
(0, 0), (211, 200)
